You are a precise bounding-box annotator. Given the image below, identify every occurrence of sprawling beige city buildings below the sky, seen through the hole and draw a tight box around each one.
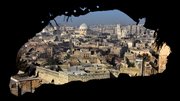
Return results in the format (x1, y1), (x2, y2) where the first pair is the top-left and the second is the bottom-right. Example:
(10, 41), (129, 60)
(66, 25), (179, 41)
(9, 15), (170, 96)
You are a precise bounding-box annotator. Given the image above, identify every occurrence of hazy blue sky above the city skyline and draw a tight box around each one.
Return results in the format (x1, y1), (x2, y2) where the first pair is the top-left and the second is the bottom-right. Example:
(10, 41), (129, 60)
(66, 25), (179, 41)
(52, 10), (144, 26)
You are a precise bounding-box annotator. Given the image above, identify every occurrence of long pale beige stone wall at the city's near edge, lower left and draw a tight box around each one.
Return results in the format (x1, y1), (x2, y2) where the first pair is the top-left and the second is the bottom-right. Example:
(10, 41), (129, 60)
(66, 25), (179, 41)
(36, 67), (110, 84)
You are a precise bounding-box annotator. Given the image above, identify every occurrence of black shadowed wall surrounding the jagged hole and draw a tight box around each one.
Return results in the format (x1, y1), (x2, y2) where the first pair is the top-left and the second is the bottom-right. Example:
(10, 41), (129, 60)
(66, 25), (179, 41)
(0, 0), (179, 99)
